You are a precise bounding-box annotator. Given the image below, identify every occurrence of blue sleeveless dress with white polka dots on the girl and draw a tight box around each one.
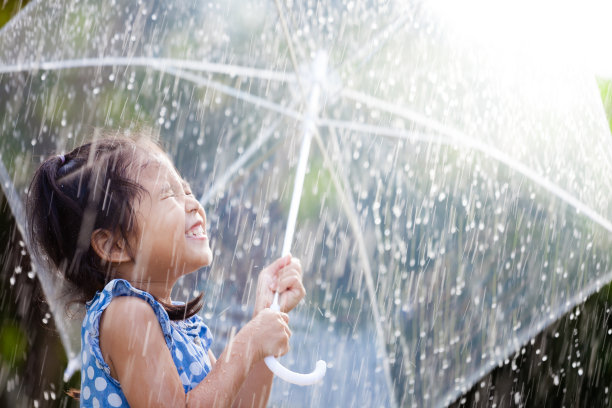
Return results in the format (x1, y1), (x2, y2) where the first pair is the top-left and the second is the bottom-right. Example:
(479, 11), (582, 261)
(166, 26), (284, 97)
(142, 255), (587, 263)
(80, 279), (212, 407)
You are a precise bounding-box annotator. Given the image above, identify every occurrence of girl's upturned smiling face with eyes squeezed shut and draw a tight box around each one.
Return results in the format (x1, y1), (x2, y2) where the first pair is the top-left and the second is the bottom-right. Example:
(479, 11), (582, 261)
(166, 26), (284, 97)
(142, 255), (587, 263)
(132, 154), (212, 282)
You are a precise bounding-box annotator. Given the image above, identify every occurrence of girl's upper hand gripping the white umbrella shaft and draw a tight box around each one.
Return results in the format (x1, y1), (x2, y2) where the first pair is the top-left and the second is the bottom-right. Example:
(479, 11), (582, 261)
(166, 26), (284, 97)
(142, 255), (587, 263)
(255, 254), (306, 315)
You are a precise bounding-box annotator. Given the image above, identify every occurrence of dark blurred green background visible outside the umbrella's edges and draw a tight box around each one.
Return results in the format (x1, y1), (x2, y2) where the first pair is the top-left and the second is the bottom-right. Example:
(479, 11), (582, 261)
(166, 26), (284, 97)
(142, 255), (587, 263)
(0, 0), (612, 407)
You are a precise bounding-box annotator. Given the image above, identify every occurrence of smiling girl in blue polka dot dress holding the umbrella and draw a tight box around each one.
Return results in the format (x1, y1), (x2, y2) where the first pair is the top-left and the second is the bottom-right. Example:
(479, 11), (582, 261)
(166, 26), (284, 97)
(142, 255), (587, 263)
(27, 132), (305, 407)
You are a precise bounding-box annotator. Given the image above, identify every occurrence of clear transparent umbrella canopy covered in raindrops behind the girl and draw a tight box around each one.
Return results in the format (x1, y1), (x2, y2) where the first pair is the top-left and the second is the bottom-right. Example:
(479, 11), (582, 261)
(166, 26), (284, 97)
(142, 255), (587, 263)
(0, 0), (612, 406)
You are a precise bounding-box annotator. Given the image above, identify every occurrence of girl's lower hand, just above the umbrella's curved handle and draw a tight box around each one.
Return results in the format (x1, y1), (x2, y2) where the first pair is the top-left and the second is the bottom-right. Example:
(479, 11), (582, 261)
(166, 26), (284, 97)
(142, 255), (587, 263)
(236, 309), (291, 361)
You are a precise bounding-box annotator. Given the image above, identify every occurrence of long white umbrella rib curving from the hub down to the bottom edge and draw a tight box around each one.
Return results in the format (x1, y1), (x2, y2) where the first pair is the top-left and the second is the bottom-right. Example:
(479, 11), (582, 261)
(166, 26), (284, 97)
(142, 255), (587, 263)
(313, 131), (397, 407)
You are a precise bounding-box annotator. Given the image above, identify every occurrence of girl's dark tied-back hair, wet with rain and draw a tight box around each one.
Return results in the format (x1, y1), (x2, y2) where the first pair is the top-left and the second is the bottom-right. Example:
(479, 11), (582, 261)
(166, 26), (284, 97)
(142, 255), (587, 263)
(26, 132), (202, 320)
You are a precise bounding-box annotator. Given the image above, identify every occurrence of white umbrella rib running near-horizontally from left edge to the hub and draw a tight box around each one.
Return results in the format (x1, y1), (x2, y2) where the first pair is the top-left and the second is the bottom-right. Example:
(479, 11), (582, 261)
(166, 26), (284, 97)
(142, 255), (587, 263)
(0, 57), (296, 83)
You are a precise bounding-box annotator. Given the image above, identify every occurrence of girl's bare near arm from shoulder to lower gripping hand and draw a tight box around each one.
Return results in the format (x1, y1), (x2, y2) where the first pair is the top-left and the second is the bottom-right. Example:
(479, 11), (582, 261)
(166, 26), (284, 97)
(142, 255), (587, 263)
(100, 297), (290, 408)
